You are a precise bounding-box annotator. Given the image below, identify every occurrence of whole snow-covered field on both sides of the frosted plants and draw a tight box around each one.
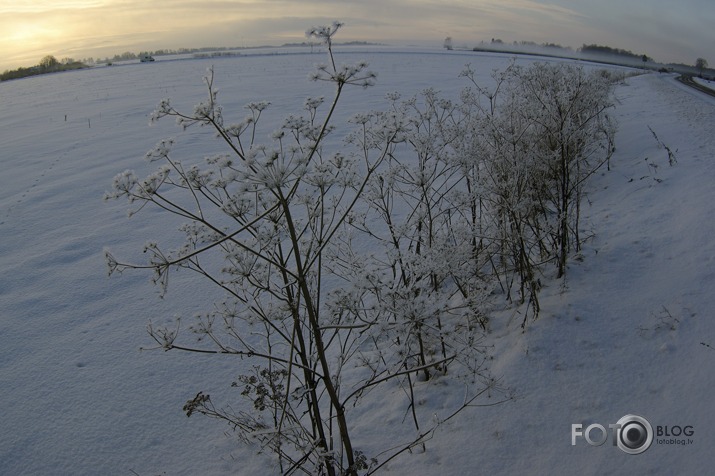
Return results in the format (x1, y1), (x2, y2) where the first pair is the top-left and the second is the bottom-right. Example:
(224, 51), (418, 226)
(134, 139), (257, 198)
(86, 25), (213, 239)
(0, 48), (715, 475)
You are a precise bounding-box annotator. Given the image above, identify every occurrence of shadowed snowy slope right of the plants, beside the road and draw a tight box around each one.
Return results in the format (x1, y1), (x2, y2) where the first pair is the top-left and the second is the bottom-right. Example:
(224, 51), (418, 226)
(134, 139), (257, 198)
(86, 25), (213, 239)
(412, 71), (715, 474)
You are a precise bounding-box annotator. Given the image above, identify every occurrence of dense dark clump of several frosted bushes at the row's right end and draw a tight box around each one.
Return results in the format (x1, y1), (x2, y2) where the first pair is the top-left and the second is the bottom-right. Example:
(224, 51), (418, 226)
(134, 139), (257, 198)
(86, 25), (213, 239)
(462, 63), (616, 322)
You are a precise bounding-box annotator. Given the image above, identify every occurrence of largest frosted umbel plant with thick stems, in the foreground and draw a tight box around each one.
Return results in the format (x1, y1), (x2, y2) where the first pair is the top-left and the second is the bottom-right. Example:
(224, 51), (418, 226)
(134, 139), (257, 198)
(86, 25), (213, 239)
(106, 23), (504, 475)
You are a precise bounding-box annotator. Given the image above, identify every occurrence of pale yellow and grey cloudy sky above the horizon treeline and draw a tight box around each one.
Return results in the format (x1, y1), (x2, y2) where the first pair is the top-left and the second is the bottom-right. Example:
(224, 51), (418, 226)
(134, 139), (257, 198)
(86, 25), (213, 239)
(0, 0), (715, 71)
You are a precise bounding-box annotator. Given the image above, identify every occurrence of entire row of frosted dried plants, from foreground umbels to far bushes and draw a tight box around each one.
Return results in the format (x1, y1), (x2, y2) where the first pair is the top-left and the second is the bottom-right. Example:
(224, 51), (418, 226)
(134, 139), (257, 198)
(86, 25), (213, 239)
(105, 23), (615, 475)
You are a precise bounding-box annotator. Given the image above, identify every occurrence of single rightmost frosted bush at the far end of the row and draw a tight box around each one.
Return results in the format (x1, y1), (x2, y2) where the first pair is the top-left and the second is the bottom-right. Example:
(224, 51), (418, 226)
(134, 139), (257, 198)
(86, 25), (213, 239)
(519, 64), (615, 277)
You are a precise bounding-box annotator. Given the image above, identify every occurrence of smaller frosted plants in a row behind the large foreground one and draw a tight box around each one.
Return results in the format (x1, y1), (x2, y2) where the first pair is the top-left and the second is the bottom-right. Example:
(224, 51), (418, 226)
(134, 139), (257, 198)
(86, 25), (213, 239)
(348, 63), (615, 330)
